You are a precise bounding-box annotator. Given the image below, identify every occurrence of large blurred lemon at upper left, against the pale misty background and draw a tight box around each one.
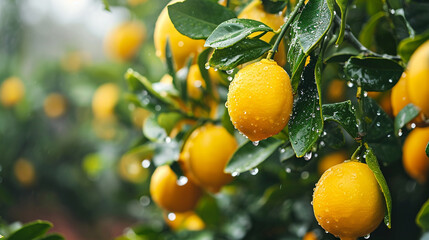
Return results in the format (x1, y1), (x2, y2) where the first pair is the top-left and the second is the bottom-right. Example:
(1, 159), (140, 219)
(104, 21), (146, 61)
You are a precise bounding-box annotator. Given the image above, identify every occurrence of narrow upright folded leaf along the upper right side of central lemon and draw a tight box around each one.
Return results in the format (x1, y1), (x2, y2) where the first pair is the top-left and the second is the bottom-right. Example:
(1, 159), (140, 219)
(286, 21), (306, 93)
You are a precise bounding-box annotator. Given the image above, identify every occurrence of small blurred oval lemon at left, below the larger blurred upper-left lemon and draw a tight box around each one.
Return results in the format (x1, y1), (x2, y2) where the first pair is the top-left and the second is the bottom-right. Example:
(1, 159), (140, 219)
(92, 83), (119, 119)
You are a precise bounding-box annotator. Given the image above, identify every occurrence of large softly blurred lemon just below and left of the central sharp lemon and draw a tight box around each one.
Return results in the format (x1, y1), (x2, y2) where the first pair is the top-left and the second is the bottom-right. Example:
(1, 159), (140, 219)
(180, 124), (238, 193)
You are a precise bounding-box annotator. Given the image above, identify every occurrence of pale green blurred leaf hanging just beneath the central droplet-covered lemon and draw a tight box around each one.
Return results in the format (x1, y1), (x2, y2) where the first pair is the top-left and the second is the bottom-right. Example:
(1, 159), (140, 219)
(225, 138), (283, 173)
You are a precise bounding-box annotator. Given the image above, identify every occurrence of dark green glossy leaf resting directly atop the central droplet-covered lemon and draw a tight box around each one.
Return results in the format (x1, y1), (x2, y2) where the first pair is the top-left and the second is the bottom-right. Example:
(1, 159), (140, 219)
(209, 39), (271, 70)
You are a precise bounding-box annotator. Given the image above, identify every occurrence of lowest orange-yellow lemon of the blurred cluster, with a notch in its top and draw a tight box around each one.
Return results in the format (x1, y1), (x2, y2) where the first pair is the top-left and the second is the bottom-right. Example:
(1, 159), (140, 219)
(150, 165), (201, 212)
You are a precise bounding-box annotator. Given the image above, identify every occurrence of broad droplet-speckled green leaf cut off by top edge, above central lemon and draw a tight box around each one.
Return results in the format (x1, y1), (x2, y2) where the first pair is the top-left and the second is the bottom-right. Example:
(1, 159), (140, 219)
(297, 0), (334, 54)
